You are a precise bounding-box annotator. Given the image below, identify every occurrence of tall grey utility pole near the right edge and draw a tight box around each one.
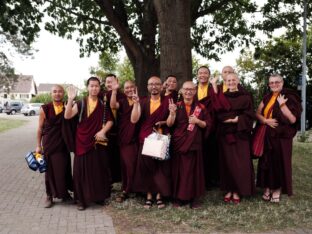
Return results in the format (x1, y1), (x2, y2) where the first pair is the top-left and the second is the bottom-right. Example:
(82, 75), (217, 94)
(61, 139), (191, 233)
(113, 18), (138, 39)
(301, 0), (308, 135)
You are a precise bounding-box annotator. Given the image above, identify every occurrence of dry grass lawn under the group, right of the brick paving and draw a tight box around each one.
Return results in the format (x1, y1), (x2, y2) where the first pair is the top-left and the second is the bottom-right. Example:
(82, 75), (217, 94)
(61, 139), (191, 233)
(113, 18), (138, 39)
(105, 142), (312, 233)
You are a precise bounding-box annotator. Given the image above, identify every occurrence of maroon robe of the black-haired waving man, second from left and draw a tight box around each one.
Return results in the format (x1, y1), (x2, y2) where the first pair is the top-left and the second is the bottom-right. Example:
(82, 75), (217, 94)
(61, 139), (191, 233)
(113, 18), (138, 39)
(74, 99), (112, 206)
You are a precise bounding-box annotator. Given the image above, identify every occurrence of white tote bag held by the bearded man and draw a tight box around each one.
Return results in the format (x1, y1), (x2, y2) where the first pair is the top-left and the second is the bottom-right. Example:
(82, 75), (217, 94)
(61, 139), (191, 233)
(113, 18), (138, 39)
(142, 132), (170, 160)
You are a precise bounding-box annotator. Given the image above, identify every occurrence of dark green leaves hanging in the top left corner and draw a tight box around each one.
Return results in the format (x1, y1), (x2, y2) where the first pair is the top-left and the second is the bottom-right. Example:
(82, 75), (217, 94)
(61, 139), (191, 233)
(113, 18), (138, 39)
(0, 0), (44, 86)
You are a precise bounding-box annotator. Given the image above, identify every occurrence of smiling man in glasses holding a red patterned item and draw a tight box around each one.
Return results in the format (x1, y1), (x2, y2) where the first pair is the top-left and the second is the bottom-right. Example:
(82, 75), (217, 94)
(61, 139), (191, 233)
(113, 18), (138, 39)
(167, 81), (211, 208)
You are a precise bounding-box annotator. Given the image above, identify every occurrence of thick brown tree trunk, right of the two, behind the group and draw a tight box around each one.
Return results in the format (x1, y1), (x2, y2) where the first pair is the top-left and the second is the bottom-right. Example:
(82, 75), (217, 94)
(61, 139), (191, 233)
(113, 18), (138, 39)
(154, 0), (192, 86)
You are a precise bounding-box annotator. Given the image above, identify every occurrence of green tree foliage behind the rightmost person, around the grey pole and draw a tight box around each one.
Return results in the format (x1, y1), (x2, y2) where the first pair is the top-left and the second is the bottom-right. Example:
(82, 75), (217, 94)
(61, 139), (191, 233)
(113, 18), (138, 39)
(236, 29), (312, 106)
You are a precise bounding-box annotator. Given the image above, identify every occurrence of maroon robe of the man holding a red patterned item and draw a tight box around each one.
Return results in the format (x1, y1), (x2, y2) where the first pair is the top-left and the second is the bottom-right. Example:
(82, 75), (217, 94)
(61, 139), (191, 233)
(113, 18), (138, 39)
(171, 101), (211, 201)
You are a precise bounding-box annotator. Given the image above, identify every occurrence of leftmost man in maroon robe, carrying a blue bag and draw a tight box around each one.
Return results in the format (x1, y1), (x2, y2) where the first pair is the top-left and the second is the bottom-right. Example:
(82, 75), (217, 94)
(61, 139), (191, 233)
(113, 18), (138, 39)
(36, 85), (72, 208)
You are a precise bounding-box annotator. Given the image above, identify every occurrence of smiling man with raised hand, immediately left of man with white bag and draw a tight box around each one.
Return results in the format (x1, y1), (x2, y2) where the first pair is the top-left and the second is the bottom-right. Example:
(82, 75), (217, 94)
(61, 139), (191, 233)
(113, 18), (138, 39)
(110, 80), (139, 202)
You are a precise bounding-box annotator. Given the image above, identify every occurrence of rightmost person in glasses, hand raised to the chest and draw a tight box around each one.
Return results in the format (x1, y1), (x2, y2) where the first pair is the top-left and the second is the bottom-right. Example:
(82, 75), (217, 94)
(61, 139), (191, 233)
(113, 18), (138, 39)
(256, 74), (302, 203)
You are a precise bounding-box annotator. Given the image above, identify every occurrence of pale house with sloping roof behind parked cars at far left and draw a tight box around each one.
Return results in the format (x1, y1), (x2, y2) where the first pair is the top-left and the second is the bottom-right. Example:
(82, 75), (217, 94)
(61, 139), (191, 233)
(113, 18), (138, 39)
(0, 75), (37, 102)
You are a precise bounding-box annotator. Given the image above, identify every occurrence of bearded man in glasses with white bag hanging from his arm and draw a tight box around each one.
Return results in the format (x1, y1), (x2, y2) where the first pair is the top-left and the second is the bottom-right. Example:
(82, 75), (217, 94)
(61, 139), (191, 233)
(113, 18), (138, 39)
(131, 76), (171, 209)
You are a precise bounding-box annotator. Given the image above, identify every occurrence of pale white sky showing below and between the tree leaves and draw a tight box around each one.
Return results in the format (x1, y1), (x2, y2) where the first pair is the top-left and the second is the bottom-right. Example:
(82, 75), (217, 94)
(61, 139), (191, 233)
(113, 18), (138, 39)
(11, 30), (244, 88)
